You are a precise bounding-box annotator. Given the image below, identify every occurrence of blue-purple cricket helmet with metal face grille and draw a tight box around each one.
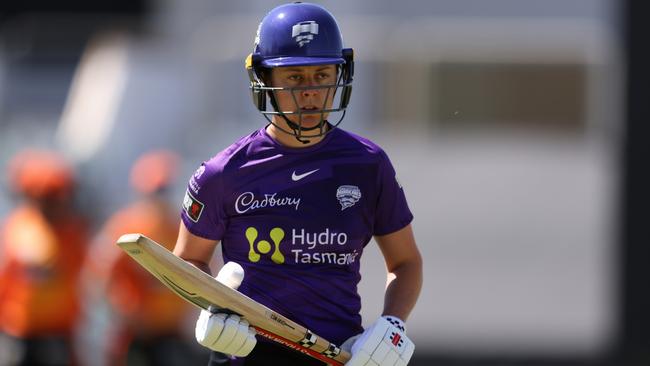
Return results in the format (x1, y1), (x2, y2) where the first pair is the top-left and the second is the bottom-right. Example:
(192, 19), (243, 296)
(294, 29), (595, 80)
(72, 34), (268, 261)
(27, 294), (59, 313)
(246, 2), (354, 140)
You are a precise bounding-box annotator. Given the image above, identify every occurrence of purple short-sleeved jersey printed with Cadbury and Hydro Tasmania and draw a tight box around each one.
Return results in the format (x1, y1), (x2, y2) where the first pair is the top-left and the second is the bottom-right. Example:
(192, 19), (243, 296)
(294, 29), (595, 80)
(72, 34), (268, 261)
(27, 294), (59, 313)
(182, 128), (413, 344)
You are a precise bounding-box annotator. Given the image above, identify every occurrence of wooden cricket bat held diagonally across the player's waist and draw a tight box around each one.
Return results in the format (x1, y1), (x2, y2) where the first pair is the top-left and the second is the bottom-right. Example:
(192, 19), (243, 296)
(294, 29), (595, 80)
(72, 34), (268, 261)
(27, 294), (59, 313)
(117, 234), (350, 365)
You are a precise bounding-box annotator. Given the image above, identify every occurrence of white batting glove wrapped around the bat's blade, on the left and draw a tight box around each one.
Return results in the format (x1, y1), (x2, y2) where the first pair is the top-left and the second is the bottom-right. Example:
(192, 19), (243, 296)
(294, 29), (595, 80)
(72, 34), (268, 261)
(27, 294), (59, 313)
(195, 262), (257, 357)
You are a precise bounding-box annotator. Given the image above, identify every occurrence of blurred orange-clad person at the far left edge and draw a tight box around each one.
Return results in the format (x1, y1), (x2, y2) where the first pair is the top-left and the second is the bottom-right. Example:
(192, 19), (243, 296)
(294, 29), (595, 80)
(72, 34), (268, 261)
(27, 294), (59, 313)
(0, 150), (89, 365)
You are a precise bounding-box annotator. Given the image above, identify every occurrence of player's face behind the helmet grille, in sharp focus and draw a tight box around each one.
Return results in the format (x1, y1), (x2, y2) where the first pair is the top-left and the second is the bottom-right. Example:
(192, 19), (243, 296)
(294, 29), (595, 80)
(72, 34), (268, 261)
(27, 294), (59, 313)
(271, 65), (337, 128)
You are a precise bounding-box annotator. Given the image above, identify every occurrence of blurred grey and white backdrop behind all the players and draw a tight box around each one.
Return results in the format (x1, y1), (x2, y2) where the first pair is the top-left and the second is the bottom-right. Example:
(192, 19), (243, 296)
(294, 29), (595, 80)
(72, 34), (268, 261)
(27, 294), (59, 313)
(0, 0), (650, 365)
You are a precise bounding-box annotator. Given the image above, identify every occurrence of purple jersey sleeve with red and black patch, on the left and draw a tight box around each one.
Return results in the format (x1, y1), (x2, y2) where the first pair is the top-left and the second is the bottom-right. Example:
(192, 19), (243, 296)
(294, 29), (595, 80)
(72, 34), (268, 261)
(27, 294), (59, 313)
(181, 162), (227, 240)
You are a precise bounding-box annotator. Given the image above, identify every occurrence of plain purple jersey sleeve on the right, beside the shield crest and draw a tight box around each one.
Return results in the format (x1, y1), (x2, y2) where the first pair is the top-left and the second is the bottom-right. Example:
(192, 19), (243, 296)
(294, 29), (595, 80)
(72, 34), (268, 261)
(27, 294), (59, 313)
(373, 151), (413, 235)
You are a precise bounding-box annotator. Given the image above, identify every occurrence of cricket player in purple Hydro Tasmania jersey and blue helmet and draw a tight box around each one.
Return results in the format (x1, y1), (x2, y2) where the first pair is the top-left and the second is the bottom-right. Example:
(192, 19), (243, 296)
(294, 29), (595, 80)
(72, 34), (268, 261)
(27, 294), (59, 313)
(174, 2), (422, 365)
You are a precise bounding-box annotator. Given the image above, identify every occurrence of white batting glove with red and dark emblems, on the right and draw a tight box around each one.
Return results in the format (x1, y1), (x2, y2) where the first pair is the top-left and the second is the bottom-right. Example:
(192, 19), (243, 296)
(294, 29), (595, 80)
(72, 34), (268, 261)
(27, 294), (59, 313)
(341, 315), (415, 366)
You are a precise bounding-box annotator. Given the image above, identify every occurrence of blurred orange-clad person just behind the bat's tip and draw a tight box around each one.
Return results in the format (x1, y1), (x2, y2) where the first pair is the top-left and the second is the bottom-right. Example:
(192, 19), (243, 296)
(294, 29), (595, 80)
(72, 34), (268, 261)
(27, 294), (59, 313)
(89, 150), (208, 366)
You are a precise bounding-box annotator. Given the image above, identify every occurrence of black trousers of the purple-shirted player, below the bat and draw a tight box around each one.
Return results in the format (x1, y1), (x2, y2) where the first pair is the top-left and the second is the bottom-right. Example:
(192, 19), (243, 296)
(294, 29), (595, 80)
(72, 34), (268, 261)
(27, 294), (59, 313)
(208, 341), (325, 366)
